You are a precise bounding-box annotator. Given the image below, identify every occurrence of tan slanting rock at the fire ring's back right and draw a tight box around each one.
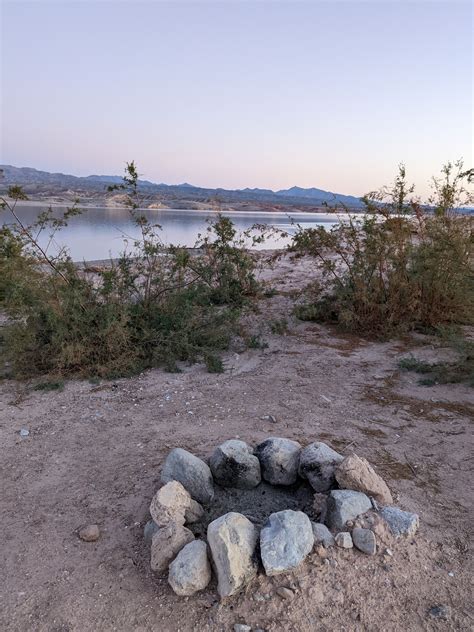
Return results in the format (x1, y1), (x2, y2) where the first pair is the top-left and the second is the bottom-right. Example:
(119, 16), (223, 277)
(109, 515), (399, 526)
(336, 454), (393, 505)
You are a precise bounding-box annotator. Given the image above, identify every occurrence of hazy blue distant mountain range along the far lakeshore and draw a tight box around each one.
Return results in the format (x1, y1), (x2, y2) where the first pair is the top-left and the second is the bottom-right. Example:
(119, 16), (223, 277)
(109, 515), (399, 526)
(0, 165), (362, 208)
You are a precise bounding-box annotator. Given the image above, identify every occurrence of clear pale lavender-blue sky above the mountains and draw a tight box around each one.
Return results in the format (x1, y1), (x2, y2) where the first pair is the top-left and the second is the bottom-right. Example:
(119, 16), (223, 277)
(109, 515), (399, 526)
(0, 0), (473, 195)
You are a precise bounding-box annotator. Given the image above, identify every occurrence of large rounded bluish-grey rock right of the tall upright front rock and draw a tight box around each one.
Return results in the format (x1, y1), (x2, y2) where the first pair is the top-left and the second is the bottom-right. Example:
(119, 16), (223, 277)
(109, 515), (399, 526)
(260, 509), (314, 576)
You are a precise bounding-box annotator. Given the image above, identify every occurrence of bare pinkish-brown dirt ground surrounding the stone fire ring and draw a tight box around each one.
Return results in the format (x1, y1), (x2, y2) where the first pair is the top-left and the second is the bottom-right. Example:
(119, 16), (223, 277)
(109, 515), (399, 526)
(0, 254), (474, 632)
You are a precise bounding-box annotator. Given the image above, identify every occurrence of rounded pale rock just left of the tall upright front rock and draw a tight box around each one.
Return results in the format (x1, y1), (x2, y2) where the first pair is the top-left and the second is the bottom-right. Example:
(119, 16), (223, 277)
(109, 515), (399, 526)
(168, 540), (211, 597)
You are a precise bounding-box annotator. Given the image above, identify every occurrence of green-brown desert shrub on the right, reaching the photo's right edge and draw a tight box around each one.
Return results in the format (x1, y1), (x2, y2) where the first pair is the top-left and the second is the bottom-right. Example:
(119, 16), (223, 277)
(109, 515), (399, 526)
(290, 162), (474, 338)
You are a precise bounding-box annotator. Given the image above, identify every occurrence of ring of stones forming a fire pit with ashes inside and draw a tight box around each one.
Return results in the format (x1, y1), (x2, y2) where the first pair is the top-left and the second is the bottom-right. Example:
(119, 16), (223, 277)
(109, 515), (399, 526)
(144, 437), (419, 599)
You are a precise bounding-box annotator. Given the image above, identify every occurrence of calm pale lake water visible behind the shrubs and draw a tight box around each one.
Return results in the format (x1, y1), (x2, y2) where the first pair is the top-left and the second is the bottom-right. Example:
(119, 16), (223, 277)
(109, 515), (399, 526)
(0, 205), (337, 261)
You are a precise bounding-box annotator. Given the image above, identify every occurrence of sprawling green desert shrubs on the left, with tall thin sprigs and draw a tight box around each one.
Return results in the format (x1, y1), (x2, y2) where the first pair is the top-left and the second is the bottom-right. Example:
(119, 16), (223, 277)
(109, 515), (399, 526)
(0, 163), (261, 377)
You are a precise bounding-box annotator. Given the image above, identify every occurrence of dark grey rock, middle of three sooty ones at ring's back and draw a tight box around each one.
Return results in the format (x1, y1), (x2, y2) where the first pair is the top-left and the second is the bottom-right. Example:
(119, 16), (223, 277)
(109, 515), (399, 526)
(255, 437), (301, 485)
